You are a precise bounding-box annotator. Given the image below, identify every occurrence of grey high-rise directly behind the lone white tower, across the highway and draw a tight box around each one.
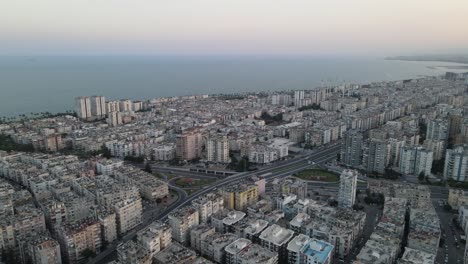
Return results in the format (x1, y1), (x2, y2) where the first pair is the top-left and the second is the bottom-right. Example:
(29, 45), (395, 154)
(340, 130), (364, 167)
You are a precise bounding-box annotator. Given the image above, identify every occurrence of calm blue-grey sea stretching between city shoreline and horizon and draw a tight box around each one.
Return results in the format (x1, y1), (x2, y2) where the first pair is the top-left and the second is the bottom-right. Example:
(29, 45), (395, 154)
(0, 56), (468, 117)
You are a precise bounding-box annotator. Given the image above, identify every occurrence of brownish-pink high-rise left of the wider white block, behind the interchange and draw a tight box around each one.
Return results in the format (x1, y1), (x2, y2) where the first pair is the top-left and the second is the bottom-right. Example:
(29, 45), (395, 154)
(176, 130), (203, 160)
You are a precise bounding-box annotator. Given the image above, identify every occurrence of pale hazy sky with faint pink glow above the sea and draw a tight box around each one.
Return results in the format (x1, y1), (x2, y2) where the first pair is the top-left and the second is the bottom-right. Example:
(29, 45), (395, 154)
(0, 0), (468, 55)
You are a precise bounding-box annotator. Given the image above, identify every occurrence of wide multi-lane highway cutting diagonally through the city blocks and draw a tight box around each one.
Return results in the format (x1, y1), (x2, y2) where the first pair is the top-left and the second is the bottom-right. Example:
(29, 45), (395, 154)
(89, 142), (340, 264)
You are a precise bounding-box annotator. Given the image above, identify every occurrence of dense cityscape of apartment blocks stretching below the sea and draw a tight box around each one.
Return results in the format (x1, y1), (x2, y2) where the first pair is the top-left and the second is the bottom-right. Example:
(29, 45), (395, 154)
(0, 72), (468, 264)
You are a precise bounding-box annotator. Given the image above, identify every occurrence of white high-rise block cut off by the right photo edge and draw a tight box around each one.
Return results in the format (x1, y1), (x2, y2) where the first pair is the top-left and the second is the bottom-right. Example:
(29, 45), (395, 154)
(444, 145), (468, 181)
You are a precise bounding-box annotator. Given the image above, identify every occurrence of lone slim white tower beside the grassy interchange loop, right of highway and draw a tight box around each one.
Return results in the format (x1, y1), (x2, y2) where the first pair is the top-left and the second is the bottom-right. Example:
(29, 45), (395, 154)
(338, 170), (358, 208)
